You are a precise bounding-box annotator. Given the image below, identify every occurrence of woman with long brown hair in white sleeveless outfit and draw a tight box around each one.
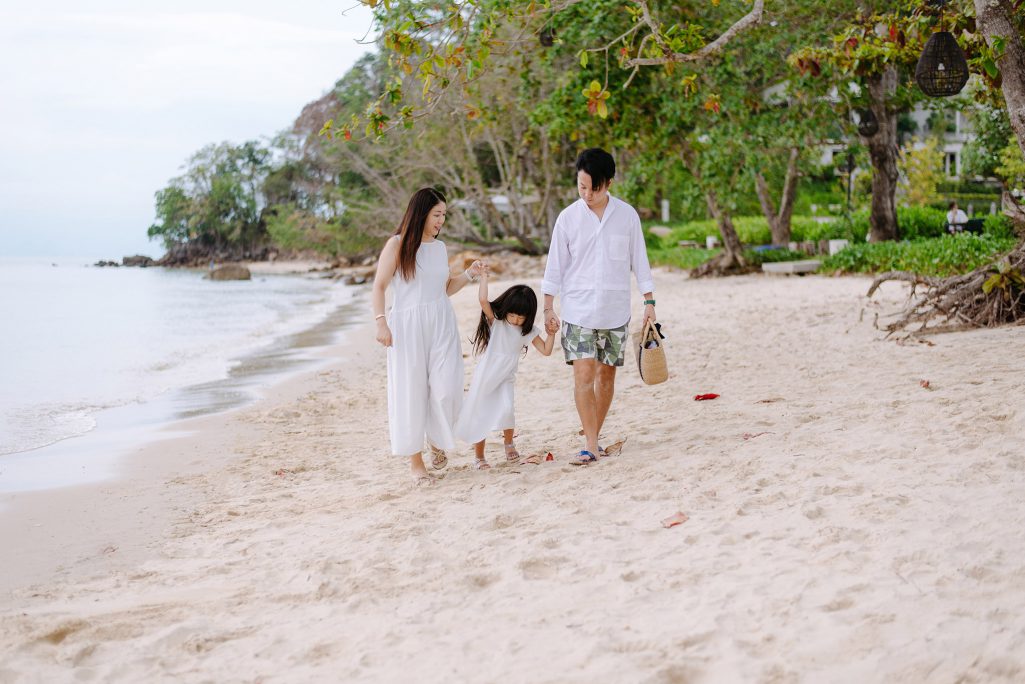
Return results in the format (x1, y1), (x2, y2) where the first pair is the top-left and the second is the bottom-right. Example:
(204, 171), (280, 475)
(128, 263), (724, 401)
(373, 188), (482, 487)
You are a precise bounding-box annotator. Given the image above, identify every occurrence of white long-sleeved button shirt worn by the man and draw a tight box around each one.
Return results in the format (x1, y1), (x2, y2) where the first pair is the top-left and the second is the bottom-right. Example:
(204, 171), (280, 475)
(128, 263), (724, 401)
(541, 195), (655, 329)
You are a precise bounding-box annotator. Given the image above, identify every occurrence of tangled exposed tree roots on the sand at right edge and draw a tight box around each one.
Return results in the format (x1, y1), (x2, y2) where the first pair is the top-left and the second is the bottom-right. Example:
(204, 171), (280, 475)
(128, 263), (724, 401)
(867, 243), (1025, 336)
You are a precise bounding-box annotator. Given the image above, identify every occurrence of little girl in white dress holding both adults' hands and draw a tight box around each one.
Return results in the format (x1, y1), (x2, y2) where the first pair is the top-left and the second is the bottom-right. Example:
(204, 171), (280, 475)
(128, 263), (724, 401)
(456, 266), (556, 470)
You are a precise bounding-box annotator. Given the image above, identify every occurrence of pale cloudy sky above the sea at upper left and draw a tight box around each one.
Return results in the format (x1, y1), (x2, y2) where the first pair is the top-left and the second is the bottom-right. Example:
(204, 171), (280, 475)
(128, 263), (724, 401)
(0, 0), (371, 260)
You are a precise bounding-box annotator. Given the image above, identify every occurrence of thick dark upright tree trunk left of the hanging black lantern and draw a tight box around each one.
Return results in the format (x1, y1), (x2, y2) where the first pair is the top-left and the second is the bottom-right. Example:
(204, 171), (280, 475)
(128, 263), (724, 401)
(865, 67), (898, 242)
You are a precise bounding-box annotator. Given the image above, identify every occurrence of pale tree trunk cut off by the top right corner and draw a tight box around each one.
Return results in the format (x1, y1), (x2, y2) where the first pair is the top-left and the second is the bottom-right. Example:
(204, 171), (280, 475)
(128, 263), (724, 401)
(975, 0), (1025, 154)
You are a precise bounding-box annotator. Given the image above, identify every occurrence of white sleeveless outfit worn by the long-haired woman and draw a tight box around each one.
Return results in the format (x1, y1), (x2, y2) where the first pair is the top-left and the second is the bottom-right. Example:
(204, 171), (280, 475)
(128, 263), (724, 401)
(387, 240), (463, 456)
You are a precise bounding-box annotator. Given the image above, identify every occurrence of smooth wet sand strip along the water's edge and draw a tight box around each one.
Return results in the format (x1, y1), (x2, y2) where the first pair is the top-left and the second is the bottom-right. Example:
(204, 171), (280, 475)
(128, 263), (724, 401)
(0, 309), (381, 597)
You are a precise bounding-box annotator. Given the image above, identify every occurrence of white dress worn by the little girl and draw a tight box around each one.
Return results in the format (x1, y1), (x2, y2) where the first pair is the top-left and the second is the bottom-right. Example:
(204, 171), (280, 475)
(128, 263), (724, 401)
(455, 318), (541, 444)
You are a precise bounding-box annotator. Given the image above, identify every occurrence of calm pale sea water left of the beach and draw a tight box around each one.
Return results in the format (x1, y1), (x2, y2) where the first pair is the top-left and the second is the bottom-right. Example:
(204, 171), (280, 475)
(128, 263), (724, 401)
(0, 259), (354, 455)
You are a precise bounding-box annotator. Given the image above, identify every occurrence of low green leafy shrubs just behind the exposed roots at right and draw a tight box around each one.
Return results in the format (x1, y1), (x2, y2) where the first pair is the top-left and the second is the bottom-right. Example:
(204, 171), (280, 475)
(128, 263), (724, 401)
(822, 233), (1016, 276)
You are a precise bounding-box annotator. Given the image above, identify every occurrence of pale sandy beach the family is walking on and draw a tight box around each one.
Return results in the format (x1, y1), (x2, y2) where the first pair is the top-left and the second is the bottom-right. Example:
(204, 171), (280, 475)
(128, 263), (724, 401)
(0, 271), (1025, 683)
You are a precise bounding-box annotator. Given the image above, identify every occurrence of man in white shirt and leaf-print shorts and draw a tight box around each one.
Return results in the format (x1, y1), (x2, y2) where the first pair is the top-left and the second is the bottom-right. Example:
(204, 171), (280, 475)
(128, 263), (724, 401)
(541, 148), (656, 466)
